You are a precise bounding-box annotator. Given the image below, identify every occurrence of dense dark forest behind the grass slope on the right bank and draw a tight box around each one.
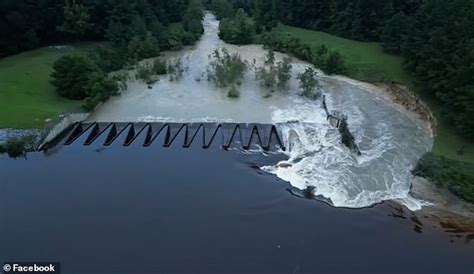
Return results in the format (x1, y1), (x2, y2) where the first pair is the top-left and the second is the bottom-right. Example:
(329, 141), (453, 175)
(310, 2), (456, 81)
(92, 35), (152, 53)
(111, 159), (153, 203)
(210, 0), (474, 140)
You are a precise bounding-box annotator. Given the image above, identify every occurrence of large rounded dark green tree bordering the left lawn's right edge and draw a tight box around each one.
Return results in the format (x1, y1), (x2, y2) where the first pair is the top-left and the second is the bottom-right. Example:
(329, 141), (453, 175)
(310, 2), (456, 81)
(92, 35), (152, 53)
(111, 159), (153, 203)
(51, 55), (100, 100)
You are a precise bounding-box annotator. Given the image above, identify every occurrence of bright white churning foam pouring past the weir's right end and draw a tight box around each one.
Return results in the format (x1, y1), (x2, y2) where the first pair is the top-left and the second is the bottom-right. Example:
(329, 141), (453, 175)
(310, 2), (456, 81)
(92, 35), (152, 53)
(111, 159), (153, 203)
(262, 93), (434, 210)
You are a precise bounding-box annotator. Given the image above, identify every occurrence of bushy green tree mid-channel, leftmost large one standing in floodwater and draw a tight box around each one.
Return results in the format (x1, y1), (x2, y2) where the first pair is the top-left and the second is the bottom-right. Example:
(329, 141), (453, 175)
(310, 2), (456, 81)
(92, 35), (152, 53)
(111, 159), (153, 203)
(208, 48), (247, 88)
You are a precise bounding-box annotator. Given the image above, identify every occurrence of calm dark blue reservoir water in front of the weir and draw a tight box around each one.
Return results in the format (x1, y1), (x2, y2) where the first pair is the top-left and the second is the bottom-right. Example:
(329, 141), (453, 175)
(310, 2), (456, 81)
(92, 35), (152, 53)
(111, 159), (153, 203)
(0, 132), (474, 274)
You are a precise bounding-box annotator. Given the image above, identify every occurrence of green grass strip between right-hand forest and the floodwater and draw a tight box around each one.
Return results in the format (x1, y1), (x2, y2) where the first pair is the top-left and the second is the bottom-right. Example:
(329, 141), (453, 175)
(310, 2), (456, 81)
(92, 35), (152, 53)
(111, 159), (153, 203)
(278, 25), (474, 163)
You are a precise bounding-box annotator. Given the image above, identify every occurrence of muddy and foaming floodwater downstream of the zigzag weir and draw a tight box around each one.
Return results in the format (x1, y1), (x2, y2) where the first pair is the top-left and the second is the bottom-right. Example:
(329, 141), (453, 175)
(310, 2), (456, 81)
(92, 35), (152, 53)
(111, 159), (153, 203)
(89, 14), (432, 209)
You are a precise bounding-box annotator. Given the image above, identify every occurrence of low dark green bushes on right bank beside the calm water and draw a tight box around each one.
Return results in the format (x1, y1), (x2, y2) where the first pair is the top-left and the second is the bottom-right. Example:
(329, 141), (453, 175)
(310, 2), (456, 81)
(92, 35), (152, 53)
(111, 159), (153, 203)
(413, 153), (474, 203)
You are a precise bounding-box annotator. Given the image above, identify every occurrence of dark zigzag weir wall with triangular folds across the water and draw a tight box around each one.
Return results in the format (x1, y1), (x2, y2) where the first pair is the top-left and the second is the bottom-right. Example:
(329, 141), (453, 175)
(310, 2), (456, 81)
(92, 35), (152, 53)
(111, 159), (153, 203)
(50, 122), (286, 151)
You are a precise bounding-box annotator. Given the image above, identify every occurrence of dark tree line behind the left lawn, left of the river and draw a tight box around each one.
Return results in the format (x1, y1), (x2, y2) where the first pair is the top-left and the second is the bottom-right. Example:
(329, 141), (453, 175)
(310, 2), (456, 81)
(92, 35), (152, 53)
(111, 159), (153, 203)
(0, 0), (202, 57)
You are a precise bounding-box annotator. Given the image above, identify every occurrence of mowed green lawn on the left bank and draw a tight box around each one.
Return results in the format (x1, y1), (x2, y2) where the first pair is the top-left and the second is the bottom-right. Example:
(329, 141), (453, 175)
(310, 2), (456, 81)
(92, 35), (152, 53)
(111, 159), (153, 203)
(0, 43), (96, 128)
